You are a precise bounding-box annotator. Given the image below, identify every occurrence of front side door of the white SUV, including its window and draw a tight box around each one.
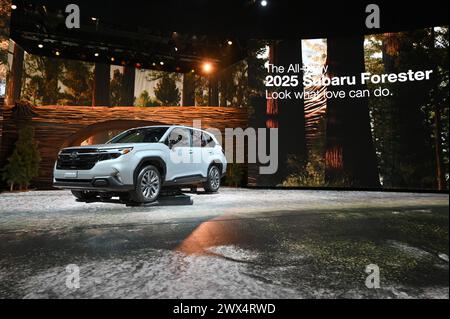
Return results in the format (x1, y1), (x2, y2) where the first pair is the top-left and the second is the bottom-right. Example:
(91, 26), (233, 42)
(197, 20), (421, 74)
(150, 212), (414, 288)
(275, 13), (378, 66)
(167, 127), (195, 180)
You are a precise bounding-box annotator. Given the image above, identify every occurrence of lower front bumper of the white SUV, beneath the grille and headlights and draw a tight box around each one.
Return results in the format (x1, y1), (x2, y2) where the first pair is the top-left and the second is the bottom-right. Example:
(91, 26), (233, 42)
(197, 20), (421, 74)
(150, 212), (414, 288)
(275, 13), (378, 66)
(53, 176), (134, 192)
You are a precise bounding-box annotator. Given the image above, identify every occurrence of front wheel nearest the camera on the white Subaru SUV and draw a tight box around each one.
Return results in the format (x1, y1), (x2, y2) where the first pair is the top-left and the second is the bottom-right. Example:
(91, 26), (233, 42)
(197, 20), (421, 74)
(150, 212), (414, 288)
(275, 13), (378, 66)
(130, 165), (162, 203)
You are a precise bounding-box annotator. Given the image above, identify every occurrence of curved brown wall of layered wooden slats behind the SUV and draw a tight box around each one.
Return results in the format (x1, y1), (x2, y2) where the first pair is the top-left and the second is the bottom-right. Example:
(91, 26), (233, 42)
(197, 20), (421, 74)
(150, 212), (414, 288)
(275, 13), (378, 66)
(0, 106), (248, 188)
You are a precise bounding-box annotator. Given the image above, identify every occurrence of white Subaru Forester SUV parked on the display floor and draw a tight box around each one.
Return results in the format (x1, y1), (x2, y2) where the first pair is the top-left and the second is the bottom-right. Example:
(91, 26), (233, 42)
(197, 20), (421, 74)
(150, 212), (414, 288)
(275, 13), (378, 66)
(53, 126), (227, 203)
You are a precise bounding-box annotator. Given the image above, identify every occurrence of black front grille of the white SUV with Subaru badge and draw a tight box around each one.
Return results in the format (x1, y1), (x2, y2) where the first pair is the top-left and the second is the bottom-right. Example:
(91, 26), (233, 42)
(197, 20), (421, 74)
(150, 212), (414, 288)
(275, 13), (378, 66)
(56, 148), (101, 170)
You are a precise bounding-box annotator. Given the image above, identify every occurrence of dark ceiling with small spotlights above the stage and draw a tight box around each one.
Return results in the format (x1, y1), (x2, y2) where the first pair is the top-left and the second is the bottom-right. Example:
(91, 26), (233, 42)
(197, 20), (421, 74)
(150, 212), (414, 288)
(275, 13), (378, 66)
(11, 0), (449, 72)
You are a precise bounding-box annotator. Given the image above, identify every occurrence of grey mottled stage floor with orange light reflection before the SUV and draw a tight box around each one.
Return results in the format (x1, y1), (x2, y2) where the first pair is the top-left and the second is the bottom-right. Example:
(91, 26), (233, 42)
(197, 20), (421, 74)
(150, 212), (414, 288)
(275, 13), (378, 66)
(0, 188), (449, 298)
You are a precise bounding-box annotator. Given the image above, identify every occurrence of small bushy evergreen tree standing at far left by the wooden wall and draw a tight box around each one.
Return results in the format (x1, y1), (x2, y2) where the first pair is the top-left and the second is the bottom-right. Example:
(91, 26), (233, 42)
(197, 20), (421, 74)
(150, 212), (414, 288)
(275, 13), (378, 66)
(2, 126), (41, 191)
